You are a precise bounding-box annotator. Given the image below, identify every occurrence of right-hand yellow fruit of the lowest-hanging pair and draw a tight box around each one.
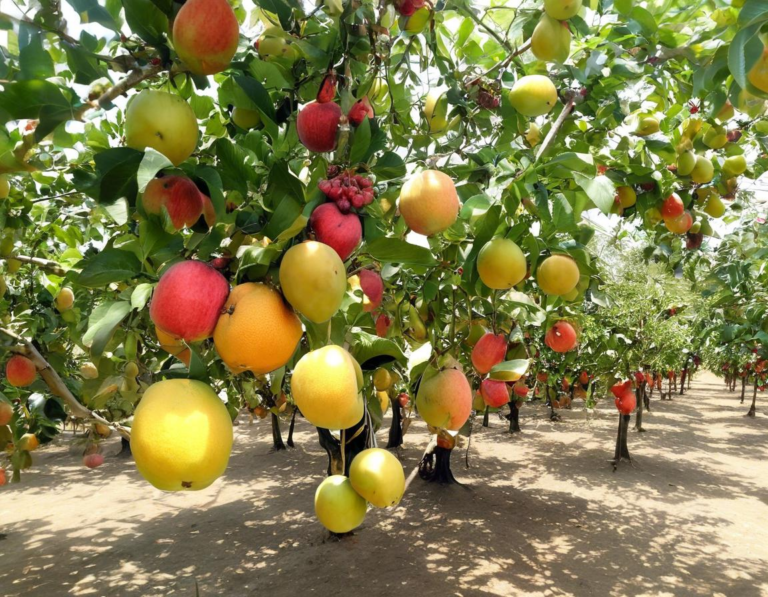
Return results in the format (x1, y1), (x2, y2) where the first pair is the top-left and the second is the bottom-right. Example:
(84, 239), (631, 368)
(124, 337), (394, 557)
(349, 448), (405, 508)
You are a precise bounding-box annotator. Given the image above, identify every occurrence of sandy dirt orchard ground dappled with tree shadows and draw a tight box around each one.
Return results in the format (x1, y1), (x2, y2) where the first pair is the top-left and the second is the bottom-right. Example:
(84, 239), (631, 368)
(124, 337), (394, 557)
(0, 374), (768, 597)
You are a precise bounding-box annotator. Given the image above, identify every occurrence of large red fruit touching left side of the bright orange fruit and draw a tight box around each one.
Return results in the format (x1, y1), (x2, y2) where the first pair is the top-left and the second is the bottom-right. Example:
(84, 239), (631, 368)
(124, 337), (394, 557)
(149, 261), (229, 342)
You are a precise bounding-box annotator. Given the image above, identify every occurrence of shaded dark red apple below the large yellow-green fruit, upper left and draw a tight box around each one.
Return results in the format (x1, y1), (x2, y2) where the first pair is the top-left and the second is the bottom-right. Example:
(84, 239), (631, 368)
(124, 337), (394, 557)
(141, 176), (204, 230)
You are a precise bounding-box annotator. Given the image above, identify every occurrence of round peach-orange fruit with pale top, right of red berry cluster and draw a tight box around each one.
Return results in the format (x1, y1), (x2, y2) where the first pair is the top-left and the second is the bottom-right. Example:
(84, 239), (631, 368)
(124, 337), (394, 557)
(399, 170), (459, 236)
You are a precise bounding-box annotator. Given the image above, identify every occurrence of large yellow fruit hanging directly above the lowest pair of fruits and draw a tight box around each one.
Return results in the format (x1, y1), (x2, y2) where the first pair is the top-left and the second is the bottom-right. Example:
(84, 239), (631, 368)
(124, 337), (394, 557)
(291, 345), (363, 429)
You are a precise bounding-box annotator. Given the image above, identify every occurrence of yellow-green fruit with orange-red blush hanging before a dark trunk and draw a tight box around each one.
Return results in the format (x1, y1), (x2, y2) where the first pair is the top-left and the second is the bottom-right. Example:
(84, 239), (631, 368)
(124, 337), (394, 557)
(416, 369), (472, 431)
